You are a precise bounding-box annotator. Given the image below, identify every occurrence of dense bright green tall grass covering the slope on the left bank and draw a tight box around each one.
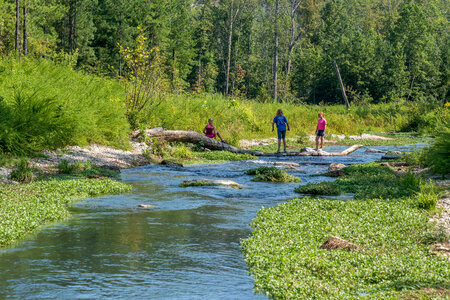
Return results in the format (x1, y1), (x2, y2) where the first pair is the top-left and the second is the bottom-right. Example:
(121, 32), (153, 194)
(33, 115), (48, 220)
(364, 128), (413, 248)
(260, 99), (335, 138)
(0, 59), (129, 154)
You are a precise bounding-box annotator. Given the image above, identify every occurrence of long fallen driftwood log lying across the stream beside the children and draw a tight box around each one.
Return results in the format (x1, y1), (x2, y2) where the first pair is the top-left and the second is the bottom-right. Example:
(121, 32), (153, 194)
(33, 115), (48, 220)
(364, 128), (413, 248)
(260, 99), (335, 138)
(140, 127), (362, 156)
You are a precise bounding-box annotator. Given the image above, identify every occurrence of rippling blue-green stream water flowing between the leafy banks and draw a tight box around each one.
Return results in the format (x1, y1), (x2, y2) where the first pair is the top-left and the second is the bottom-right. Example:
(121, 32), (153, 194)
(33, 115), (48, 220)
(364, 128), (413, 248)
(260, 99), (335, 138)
(0, 145), (420, 299)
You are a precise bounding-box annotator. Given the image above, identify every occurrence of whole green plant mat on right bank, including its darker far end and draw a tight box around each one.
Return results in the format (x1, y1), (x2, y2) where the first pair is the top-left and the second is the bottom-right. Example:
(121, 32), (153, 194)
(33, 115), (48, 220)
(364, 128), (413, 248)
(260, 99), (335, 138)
(242, 163), (450, 299)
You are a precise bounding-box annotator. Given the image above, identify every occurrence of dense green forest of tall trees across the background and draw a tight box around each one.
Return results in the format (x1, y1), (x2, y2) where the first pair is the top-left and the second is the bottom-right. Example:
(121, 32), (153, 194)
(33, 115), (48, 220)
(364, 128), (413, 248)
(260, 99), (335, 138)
(0, 0), (450, 105)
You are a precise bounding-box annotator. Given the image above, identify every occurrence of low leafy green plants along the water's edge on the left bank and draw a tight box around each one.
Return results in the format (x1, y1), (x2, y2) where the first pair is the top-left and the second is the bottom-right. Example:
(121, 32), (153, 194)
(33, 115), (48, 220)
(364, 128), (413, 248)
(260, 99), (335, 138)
(0, 178), (131, 246)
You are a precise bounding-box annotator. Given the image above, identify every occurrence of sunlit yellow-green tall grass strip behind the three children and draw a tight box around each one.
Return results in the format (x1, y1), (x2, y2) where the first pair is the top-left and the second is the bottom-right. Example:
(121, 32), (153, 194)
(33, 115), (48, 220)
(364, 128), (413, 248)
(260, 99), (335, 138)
(144, 94), (448, 143)
